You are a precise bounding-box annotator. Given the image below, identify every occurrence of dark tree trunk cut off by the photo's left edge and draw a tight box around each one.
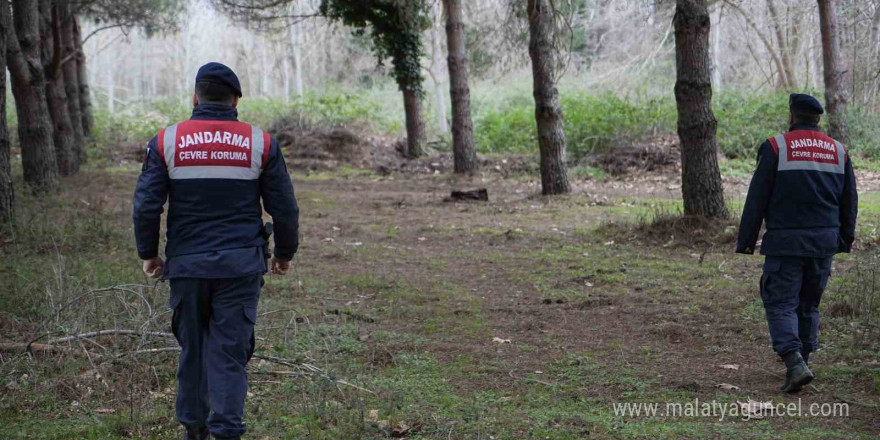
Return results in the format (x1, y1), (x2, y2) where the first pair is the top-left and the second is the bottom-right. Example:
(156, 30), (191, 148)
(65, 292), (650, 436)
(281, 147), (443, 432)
(0, 0), (15, 224)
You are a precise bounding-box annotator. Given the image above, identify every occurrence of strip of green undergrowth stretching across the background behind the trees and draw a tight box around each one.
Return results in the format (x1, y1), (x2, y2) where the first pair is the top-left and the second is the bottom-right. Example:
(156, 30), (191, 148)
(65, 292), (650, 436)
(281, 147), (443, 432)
(65, 82), (880, 160)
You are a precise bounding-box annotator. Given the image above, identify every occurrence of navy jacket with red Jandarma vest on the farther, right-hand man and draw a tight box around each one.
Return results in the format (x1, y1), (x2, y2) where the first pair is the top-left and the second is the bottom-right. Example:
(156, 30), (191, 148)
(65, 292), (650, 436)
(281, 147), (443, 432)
(736, 124), (858, 257)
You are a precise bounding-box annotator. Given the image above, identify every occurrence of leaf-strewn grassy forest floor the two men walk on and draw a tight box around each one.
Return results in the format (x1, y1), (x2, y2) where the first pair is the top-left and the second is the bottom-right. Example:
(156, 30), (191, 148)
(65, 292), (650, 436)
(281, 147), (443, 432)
(0, 158), (880, 440)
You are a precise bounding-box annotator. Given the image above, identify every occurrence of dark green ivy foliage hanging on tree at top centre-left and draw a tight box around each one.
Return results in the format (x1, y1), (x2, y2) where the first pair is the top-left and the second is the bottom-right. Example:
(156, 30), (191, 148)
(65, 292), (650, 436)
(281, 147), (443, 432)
(321, 0), (430, 95)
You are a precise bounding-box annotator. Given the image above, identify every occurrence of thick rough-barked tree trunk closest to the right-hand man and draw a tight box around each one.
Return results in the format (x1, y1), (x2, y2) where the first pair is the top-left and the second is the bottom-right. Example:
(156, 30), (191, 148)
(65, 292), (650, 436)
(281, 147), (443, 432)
(673, 0), (728, 218)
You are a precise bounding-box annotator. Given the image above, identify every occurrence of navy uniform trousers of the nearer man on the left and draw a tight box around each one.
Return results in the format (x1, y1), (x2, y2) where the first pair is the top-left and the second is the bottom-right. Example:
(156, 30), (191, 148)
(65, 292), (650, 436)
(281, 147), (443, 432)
(171, 275), (263, 439)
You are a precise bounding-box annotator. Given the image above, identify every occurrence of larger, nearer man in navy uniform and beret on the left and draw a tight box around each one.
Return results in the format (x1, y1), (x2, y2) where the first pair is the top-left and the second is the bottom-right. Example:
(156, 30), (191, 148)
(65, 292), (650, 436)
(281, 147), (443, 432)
(134, 63), (299, 440)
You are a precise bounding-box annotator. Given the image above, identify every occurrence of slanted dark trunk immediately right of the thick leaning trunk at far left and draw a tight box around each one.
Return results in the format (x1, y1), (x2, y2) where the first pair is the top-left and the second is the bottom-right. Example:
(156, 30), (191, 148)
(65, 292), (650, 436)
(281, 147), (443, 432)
(40, 0), (79, 176)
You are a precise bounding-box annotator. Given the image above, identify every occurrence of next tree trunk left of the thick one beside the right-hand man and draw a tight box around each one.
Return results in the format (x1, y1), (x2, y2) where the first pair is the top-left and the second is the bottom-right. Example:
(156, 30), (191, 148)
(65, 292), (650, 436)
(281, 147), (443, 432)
(528, 0), (571, 195)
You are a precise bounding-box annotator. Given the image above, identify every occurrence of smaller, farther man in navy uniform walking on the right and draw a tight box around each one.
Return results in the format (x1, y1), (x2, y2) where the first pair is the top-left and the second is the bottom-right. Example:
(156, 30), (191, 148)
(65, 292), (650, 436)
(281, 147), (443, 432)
(736, 94), (858, 393)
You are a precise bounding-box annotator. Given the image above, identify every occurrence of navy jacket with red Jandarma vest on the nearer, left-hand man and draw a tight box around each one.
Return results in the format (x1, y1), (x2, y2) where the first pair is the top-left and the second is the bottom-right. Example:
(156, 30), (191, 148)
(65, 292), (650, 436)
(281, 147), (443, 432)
(134, 104), (299, 278)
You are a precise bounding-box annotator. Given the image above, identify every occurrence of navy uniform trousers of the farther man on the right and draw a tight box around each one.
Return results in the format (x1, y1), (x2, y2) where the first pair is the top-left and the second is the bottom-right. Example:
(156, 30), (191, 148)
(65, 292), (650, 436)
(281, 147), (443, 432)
(761, 255), (832, 355)
